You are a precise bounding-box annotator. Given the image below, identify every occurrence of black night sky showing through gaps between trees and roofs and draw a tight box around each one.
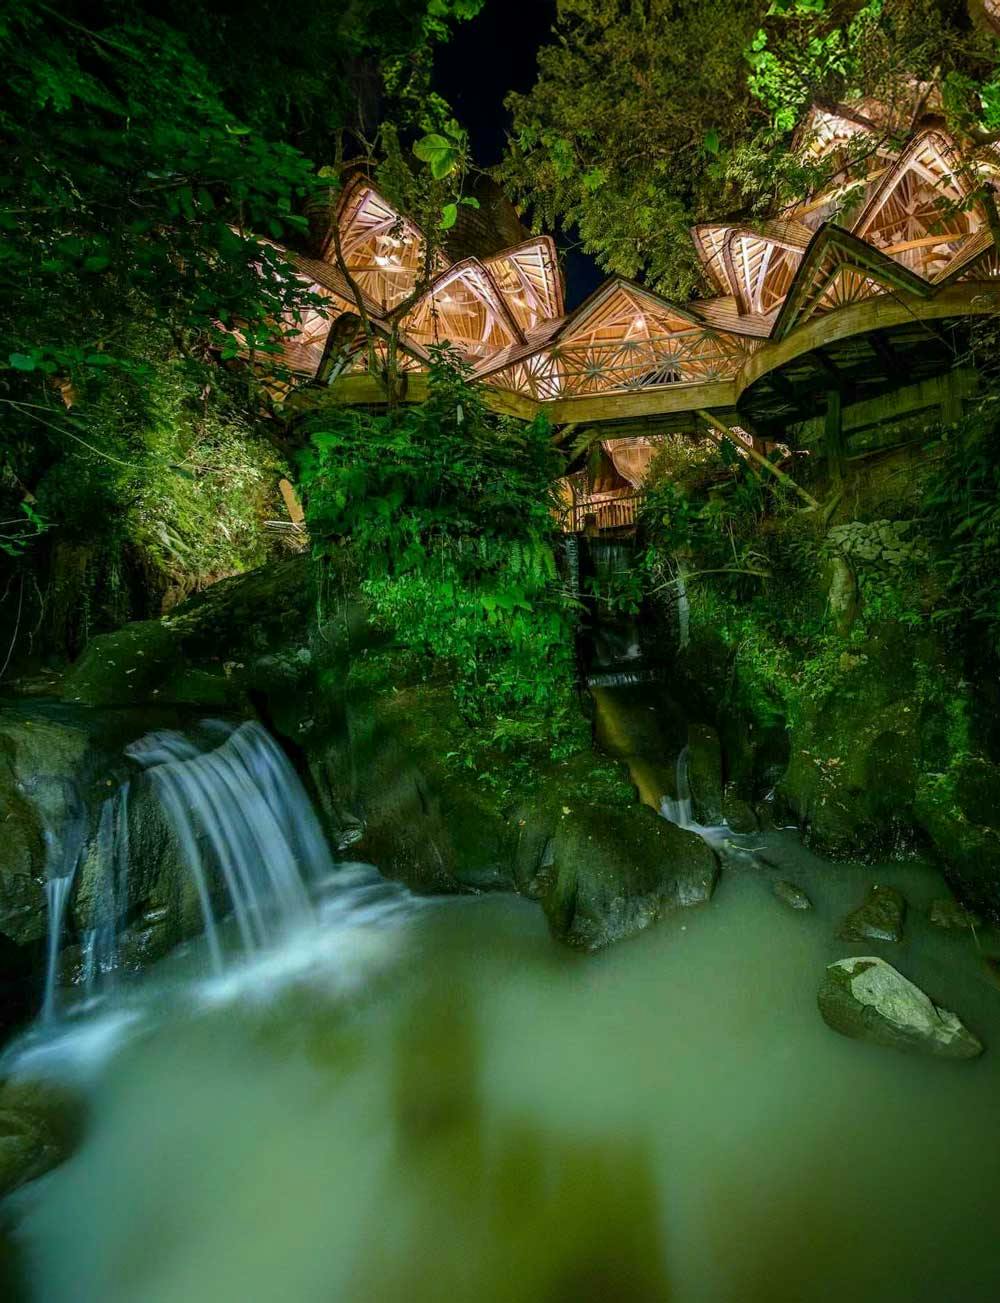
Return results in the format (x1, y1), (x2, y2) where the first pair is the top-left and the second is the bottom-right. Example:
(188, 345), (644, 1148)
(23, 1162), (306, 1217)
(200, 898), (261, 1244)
(434, 0), (605, 308)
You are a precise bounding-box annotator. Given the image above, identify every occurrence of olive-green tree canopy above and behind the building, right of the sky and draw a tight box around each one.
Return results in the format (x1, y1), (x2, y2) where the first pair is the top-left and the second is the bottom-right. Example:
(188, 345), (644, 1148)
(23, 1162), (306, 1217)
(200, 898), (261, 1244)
(502, 0), (1000, 298)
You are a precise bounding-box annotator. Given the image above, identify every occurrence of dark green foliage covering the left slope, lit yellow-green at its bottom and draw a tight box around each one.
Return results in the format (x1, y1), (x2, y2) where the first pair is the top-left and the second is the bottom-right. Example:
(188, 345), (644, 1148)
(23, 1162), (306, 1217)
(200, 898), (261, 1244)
(0, 0), (481, 650)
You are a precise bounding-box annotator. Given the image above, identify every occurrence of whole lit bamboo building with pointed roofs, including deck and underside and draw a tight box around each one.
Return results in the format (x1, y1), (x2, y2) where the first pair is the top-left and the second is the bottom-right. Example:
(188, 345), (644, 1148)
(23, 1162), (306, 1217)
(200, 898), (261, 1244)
(269, 102), (1000, 529)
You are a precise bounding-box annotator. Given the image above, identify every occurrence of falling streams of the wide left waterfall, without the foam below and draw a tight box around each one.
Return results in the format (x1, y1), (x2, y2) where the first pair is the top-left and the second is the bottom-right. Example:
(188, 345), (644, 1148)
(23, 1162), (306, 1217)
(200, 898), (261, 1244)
(42, 721), (334, 1022)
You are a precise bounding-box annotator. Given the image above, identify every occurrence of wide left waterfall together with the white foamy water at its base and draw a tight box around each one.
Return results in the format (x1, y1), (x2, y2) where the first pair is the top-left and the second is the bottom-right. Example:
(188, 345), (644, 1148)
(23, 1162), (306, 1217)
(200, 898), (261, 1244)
(7, 721), (425, 1083)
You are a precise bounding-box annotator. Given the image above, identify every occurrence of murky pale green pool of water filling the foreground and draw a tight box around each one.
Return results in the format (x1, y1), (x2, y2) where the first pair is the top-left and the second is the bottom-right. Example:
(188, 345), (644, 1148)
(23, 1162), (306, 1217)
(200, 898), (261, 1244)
(7, 834), (1000, 1303)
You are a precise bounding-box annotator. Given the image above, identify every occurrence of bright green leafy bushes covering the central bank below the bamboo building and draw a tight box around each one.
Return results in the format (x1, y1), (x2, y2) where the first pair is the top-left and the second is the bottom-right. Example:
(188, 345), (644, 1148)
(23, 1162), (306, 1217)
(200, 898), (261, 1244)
(293, 348), (579, 760)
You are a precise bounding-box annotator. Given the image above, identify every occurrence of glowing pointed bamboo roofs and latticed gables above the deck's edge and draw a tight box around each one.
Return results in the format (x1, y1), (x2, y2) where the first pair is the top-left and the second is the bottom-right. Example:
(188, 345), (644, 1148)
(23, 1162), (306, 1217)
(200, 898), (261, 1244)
(268, 115), (1000, 401)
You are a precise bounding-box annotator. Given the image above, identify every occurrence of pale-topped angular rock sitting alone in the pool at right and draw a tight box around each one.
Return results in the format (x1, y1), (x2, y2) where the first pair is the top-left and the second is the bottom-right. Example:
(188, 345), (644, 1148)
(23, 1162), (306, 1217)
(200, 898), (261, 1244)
(817, 955), (983, 1059)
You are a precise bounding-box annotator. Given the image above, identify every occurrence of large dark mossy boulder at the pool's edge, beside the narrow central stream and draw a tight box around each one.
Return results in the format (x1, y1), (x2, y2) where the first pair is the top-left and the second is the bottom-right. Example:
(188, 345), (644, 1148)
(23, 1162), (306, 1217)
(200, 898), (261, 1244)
(538, 805), (718, 950)
